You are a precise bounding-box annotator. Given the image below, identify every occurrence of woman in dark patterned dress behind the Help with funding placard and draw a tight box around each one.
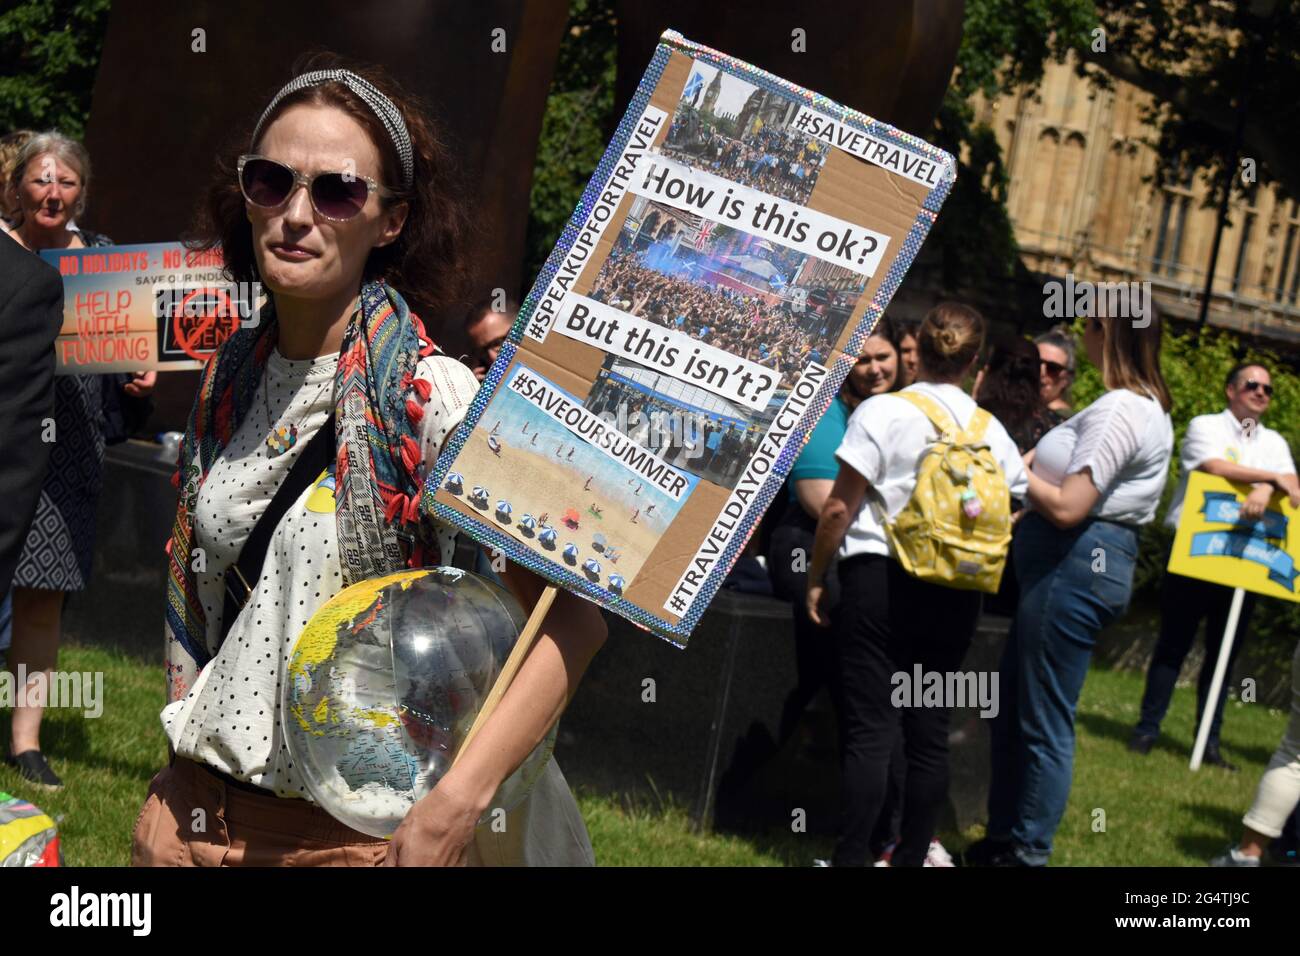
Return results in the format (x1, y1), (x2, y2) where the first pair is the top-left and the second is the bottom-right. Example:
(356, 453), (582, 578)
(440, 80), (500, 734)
(4, 133), (156, 790)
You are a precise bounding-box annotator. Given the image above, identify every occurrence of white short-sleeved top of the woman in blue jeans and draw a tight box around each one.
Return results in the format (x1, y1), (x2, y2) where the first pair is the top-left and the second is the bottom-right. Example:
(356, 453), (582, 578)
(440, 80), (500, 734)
(1034, 389), (1174, 524)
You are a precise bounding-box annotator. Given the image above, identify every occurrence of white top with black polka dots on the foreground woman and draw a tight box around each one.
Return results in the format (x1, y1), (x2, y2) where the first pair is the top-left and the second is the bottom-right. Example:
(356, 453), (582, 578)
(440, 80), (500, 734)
(161, 350), (593, 865)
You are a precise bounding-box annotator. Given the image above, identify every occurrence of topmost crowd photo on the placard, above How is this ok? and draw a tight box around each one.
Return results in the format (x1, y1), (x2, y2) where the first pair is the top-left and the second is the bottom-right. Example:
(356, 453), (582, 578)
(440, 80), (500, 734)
(660, 61), (828, 203)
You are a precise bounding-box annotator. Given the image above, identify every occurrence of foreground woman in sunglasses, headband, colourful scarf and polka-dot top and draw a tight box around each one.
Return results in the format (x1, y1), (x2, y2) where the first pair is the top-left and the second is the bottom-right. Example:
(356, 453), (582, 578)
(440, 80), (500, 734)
(131, 55), (606, 866)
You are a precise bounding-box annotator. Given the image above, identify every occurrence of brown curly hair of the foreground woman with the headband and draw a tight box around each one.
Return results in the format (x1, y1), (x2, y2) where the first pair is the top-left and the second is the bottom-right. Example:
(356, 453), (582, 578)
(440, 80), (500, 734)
(186, 52), (473, 312)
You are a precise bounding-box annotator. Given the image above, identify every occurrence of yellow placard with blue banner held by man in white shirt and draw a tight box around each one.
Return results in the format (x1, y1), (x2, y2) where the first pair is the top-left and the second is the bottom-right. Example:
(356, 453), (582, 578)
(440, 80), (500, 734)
(1169, 471), (1300, 601)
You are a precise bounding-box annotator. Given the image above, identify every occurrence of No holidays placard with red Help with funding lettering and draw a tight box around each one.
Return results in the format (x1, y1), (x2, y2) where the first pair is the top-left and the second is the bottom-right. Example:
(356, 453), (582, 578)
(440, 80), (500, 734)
(40, 242), (259, 375)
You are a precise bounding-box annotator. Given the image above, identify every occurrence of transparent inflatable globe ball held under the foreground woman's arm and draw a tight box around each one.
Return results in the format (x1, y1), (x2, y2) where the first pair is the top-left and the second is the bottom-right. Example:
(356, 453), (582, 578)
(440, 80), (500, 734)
(281, 567), (555, 838)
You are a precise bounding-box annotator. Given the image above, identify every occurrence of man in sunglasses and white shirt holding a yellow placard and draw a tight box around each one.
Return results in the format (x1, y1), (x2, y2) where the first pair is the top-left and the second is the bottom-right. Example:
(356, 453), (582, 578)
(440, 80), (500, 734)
(1128, 364), (1300, 770)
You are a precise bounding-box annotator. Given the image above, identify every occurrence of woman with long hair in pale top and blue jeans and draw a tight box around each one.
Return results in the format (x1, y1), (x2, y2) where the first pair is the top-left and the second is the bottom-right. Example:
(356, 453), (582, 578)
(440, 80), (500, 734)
(969, 316), (1174, 866)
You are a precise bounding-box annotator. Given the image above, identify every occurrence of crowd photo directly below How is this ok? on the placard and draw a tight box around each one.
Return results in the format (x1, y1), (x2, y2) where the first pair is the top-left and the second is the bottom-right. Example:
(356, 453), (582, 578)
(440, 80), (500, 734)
(589, 203), (866, 386)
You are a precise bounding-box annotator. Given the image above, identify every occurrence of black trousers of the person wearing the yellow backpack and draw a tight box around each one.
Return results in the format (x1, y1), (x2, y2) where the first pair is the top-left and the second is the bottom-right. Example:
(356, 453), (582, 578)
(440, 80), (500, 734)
(832, 554), (980, 866)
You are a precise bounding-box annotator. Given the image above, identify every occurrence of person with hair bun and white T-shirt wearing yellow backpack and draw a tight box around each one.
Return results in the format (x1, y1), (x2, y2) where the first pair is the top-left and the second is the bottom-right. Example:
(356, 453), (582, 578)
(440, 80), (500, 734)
(807, 302), (1026, 866)
